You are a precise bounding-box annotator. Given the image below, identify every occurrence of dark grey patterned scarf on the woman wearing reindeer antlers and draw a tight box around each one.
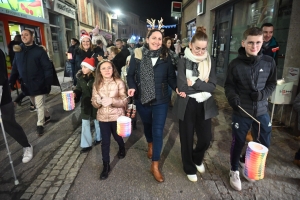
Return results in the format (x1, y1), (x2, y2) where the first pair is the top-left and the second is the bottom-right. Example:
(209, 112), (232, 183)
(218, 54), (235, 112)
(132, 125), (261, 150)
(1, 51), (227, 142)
(140, 47), (161, 104)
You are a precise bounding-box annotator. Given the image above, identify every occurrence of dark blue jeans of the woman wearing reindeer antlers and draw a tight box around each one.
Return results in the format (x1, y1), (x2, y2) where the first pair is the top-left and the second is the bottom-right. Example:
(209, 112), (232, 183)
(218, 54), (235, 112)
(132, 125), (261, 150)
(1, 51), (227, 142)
(136, 101), (168, 161)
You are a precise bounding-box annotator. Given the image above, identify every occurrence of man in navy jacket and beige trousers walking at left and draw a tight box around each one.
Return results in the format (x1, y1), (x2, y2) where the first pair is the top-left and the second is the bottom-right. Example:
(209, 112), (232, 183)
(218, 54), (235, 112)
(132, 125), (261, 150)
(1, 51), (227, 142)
(10, 29), (53, 136)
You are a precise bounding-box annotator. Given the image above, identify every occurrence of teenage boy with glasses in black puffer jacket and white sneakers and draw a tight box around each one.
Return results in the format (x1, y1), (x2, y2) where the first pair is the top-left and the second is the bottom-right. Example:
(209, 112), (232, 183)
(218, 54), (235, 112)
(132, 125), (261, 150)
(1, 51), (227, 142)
(224, 27), (276, 190)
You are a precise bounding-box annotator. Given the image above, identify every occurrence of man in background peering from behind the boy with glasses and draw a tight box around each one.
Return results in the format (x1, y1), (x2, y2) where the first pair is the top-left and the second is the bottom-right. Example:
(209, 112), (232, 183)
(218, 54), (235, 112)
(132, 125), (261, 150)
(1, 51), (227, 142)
(261, 23), (279, 65)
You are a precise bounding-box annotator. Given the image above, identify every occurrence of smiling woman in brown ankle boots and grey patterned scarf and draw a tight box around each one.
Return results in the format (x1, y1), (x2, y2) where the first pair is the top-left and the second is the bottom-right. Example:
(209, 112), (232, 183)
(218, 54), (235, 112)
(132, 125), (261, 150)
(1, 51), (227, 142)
(127, 29), (176, 182)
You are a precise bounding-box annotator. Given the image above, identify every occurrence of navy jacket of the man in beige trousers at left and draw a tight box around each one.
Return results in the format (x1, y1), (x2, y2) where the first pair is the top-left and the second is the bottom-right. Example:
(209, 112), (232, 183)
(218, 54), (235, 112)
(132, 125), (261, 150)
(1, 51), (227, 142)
(10, 44), (53, 96)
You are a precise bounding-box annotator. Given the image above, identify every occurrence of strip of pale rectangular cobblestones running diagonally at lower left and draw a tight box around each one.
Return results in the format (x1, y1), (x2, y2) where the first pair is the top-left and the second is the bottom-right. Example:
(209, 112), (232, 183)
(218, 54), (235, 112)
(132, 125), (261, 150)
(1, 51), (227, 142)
(20, 127), (87, 200)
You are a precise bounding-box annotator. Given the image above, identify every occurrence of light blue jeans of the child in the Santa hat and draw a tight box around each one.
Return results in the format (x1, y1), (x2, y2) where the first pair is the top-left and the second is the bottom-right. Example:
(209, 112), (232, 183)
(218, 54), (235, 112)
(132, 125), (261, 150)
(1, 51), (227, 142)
(80, 119), (101, 148)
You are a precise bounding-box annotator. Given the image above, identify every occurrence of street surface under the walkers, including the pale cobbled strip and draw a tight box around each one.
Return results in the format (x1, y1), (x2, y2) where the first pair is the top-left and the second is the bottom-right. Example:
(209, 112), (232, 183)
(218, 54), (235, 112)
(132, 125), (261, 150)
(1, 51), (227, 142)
(12, 88), (300, 200)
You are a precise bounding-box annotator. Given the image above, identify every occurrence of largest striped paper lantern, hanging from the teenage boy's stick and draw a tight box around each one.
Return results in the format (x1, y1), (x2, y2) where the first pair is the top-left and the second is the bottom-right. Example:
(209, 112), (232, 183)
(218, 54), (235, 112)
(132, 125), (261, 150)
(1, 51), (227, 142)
(244, 142), (269, 180)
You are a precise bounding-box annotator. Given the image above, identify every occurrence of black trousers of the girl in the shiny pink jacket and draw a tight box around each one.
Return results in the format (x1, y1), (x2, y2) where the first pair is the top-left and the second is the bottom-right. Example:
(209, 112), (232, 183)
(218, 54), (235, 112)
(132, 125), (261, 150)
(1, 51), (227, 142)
(99, 121), (125, 162)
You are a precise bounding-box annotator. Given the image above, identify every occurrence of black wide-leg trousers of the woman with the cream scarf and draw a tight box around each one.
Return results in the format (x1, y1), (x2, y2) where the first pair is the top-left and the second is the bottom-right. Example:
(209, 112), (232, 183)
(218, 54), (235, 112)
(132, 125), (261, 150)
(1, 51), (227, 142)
(179, 98), (212, 174)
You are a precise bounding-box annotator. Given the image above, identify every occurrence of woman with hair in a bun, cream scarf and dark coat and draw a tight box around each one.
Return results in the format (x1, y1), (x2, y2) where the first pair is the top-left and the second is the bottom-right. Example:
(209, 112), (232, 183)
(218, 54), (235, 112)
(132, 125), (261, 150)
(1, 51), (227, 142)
(174, 27), (218, 182)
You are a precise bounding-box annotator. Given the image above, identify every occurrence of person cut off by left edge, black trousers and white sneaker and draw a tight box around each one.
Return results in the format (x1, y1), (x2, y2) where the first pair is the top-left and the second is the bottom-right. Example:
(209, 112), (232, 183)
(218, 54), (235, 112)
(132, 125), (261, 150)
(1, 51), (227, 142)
(0, 49), (33, 163)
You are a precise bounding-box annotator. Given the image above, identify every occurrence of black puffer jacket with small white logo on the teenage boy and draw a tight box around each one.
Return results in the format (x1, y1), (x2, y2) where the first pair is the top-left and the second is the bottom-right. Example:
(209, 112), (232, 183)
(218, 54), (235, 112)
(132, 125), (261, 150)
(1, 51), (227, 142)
(224, 47), (277, 117)
